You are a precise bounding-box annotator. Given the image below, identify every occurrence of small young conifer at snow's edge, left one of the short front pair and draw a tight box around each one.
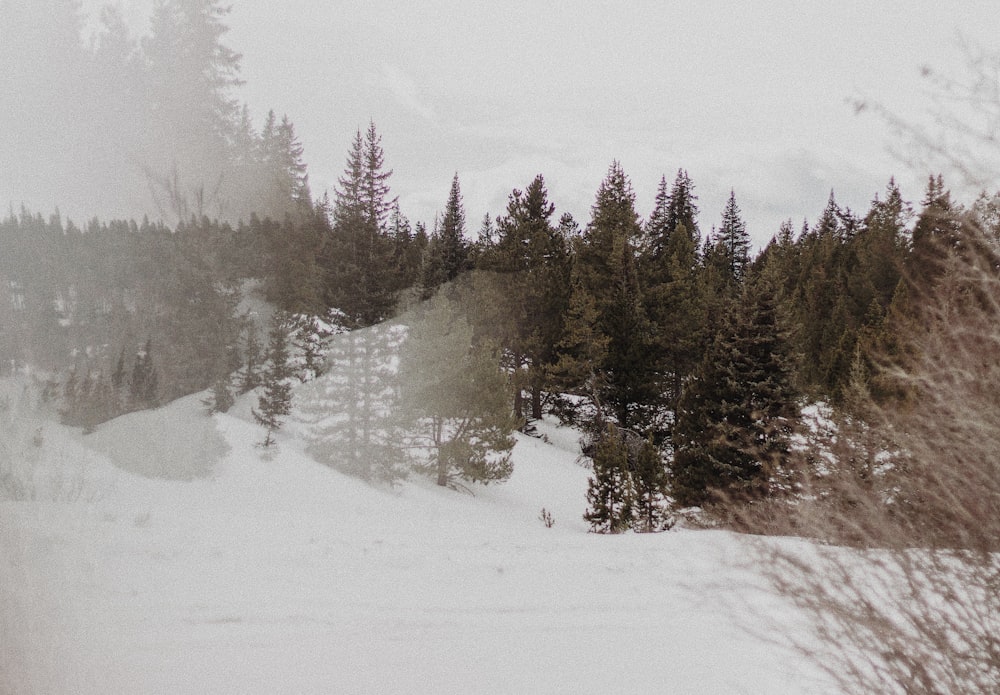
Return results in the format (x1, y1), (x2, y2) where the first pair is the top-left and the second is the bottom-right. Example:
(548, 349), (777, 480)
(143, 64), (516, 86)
(583, 424), (635, 533)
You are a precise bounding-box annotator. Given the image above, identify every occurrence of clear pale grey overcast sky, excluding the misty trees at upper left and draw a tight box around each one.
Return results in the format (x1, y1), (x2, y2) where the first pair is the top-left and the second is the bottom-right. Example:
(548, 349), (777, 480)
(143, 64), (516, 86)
(72, 0), (1000, 244)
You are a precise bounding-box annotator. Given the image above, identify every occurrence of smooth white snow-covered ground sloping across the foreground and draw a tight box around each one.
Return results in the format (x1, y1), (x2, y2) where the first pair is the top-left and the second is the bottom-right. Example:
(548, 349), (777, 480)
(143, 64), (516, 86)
(0, 397), (830, 695)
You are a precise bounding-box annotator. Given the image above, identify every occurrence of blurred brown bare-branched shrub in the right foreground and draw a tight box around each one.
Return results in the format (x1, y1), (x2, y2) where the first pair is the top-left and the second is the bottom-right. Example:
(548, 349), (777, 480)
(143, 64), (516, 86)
(737, 228), (1000, 693)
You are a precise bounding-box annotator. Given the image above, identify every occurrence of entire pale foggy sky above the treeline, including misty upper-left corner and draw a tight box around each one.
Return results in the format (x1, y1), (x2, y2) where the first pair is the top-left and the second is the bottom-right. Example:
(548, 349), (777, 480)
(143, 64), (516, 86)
(0, 0), (1000, 245)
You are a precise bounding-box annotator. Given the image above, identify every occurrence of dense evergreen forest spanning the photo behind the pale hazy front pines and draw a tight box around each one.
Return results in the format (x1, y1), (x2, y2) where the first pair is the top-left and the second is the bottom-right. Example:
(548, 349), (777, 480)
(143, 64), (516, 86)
(0, 2), (1000, 520)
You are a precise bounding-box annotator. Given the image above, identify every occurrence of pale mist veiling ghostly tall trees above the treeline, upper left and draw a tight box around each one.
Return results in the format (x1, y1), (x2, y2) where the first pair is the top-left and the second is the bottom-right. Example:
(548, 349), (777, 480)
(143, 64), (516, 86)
(0, 0), (294, 225)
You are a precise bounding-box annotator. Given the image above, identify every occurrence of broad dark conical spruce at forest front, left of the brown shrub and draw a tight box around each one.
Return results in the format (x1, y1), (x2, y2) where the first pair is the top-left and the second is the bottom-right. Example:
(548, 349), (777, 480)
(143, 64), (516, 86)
(671, 284), (798, 506)
